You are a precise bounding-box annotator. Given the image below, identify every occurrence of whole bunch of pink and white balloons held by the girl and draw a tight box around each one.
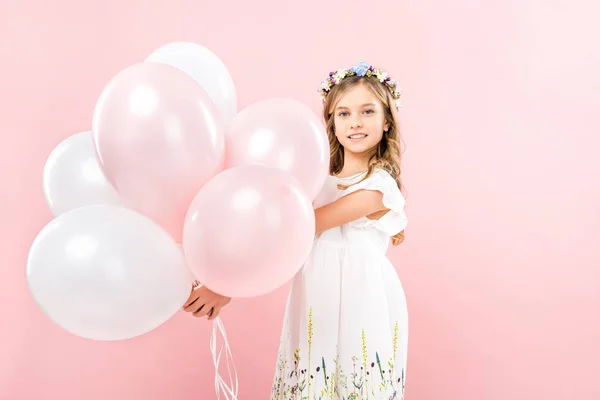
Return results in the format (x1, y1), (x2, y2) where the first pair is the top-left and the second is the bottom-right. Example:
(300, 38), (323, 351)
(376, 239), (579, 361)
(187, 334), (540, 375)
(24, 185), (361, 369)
(27, 43), (329, 340)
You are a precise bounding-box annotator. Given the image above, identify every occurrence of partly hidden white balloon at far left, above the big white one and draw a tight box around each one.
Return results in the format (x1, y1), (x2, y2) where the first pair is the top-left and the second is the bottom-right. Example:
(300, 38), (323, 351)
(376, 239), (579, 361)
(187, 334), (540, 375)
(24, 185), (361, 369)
(43, 131), (125, 216)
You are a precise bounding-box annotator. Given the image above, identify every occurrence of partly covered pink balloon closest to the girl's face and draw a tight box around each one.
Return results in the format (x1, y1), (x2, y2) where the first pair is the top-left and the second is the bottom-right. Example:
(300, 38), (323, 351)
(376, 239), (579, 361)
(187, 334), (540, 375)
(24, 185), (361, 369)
(225, 99), (329, 199)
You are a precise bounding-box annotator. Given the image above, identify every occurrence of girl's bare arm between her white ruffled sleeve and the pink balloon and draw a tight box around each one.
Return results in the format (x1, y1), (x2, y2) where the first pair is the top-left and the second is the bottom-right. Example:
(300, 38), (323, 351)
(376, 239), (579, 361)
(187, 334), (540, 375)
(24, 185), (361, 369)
(315, 190), (387, 234)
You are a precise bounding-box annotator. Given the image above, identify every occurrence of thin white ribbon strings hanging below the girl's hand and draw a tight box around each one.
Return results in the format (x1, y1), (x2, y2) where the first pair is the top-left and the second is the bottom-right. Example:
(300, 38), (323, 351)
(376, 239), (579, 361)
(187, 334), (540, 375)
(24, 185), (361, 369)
(210, 317), (238, 400)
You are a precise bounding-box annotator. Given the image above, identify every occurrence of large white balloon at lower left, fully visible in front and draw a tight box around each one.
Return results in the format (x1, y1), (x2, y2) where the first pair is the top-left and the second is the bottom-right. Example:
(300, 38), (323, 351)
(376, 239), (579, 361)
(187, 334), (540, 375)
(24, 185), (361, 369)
(27, 205), (192, 341)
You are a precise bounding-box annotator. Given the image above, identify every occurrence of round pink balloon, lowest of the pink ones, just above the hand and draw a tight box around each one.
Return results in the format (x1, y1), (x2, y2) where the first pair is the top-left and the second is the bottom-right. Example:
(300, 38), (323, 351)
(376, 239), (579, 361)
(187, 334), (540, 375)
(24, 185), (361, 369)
(183, 165), (315, 297)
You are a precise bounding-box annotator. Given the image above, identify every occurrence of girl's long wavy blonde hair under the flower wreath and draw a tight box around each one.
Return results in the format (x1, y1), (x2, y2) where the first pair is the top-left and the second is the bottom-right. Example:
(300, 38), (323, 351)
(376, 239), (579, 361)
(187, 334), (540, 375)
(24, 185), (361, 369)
(323, 76), (404, 246)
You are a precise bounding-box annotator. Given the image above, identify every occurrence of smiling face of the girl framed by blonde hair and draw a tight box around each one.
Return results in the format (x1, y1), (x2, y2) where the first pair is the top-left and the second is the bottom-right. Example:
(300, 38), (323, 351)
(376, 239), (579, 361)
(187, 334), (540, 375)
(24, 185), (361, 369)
(333, 84), (389, 156)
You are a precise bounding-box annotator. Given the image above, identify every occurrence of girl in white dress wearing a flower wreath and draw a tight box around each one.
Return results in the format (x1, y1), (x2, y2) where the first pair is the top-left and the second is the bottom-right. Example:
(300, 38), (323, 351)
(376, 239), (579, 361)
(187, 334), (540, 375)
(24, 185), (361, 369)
(271, 63), (408, 400)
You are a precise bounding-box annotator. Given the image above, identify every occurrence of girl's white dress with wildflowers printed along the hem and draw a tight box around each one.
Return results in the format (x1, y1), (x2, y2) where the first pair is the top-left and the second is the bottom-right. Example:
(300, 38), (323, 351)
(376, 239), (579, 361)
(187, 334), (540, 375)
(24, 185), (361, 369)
(271, 170), (408, 400)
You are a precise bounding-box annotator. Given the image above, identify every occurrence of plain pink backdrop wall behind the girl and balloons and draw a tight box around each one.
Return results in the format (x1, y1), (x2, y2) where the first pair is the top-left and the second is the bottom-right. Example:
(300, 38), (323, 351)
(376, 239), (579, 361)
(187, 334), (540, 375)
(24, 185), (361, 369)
(0, 0), (600, 400)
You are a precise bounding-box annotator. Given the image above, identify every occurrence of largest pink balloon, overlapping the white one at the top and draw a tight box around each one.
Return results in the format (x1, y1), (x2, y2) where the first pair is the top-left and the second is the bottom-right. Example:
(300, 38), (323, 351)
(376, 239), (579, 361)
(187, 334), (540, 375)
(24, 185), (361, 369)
(92, 63), (225, 242)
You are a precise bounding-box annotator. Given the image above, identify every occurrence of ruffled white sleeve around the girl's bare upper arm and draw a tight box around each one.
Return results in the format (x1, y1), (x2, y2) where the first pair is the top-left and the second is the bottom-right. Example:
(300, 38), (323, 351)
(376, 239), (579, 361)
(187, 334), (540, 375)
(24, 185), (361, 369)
(344, 170), (408, 236)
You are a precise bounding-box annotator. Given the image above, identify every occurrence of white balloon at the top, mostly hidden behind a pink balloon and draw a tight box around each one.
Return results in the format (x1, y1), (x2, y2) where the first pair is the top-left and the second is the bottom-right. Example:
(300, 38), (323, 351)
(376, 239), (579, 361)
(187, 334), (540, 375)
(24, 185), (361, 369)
(145, 42), (237, 123)
